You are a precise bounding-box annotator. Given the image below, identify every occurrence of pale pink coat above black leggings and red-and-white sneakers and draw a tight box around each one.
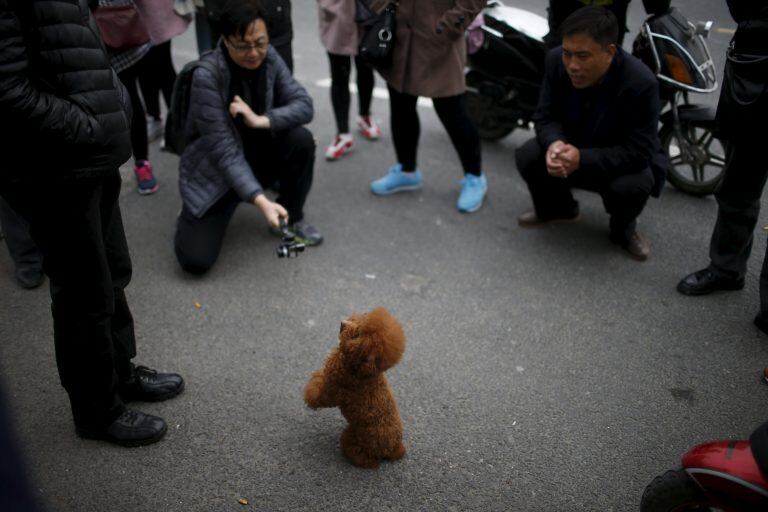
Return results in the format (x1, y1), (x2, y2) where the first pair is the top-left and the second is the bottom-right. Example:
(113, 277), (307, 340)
(317, 0), (359, 55)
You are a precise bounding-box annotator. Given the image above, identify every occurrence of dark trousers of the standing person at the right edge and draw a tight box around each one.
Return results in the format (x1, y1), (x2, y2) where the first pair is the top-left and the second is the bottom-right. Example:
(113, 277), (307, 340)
(709, 140), (768, 288)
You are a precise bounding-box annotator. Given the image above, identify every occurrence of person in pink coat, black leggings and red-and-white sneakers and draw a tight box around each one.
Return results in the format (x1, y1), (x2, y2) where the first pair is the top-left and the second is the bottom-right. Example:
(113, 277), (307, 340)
(317, 0), (381, 161)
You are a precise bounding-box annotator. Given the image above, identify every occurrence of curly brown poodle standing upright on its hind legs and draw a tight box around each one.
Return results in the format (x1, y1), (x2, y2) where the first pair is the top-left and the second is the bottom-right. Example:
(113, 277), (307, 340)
(304, 308), (405, 468)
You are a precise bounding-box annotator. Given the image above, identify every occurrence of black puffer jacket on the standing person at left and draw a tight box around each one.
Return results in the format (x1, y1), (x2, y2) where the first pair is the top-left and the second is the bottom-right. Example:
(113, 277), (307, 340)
(0, 0), (131, 180)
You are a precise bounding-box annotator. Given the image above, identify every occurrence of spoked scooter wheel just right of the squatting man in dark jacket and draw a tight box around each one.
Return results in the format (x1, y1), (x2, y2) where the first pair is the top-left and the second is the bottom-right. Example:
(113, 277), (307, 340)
(659, 123), (725, 196)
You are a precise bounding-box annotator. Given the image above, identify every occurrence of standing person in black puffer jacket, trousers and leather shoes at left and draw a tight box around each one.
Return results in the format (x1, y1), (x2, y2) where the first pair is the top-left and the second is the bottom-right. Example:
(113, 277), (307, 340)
(0, 0), (184, 446)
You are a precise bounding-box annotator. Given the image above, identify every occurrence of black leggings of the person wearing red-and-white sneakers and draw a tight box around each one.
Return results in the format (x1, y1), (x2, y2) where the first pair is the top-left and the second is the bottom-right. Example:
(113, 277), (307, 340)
(328, 52), (374, 133)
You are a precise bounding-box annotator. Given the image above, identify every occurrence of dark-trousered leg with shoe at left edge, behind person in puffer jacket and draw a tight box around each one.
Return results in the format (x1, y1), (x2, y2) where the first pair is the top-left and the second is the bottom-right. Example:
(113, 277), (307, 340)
(0, 199), (44, 289)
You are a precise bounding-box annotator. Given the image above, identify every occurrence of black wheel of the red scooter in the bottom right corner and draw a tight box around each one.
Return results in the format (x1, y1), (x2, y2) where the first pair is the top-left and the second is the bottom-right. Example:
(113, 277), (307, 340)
(640, 469), (712, 512)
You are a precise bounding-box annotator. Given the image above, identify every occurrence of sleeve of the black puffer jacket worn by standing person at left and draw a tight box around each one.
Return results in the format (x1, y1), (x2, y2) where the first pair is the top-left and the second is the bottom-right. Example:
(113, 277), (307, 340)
(0, 6), (103, 150)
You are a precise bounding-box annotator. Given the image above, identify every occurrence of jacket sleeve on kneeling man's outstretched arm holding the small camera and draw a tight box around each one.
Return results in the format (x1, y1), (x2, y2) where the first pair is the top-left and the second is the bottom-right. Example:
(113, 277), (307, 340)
(189, 67), (262, 201)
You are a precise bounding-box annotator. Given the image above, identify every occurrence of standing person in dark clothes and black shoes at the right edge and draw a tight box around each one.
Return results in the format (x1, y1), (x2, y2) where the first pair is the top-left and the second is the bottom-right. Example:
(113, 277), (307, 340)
(677, 0), (768, 334)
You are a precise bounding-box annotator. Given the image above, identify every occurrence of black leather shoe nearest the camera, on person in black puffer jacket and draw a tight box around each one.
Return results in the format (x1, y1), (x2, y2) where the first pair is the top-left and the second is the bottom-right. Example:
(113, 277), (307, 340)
(75, 409), (168, 446)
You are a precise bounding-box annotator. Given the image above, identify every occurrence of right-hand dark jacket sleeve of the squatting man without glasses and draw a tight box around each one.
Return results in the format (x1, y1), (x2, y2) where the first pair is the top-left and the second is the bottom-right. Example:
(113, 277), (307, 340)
(579, 80), (659, 177)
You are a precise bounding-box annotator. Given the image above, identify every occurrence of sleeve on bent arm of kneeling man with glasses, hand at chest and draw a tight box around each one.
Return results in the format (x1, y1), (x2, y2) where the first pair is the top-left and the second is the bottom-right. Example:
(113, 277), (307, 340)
(264, 48), (314, 132)
